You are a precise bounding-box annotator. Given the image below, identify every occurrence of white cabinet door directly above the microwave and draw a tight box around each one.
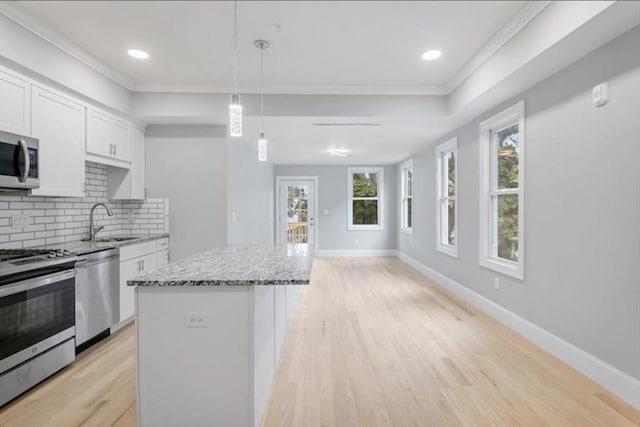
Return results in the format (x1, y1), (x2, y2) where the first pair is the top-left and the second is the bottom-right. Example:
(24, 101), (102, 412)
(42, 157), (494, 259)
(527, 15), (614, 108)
(0, 71), (31, 136)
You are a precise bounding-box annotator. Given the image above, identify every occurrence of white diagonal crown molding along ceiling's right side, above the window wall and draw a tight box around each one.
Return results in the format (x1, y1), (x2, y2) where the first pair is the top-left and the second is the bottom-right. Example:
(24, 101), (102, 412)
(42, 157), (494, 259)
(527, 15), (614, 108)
(445, 1), (551, 95)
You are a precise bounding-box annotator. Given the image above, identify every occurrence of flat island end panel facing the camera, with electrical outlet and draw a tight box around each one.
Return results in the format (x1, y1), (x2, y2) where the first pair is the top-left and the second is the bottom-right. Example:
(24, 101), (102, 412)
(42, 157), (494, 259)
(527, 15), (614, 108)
(136, 286), (253, 427)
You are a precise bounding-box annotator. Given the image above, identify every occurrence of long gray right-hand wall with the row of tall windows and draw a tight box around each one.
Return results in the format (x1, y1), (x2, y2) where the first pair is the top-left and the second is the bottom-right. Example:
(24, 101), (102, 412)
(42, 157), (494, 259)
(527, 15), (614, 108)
(398, 27), (640, 378)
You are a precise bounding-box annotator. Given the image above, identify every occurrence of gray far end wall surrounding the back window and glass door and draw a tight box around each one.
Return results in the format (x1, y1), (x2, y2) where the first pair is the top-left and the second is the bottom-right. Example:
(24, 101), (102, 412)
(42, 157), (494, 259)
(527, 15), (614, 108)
(275, 165), (397, 250)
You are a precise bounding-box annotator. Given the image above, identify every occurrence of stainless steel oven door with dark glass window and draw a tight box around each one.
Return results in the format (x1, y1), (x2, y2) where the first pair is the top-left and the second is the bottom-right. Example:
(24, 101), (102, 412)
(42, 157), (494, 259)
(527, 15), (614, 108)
(0, 270), (76, 374)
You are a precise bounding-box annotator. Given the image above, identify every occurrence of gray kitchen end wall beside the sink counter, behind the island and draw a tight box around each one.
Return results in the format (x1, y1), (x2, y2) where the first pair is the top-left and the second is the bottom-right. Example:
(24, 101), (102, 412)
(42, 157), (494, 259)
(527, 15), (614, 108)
(146, 125), (227, 261)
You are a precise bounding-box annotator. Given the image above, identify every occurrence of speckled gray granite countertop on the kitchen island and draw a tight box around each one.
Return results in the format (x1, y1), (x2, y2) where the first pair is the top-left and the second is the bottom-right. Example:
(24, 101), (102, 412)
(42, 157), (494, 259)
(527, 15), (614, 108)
(127, 245), (313, 286)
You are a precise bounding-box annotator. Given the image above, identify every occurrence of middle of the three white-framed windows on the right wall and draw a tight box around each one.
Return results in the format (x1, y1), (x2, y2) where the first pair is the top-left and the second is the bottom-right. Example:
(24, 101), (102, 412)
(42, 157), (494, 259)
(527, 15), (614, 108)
(436, 138), (458, 257)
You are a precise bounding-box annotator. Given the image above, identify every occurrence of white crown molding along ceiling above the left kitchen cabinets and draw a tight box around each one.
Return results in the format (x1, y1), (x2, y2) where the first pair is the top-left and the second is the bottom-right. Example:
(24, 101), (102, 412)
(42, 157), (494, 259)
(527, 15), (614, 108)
(0, 1), (134, 91)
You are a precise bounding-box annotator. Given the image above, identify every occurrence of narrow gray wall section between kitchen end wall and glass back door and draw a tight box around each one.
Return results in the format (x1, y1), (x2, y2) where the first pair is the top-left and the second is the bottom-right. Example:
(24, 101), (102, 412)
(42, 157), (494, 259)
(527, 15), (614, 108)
(227, 143), (275, 244)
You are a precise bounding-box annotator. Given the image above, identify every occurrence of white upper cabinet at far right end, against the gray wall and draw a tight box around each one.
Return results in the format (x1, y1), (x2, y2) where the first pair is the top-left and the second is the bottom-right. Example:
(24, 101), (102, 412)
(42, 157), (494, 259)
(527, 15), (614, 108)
(107, 128), (146, 200)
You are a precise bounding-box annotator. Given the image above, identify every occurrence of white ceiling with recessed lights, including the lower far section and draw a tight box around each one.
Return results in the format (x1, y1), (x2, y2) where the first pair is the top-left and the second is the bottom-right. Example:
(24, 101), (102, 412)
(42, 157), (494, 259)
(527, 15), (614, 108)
(6, 1), (638, 165)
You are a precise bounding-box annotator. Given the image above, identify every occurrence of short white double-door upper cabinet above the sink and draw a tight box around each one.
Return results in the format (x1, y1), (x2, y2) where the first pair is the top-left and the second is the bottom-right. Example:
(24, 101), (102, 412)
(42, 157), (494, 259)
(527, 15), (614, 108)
(87, 108), (133, 168)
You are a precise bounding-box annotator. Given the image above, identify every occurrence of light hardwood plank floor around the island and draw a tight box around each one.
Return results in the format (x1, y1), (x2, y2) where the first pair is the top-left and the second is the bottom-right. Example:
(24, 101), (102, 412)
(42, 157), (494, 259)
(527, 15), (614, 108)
(0, 258), (640, 427)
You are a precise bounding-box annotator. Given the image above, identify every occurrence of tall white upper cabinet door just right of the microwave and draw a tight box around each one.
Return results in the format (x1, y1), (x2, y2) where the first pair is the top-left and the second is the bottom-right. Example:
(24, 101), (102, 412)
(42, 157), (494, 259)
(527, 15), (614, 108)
(31, 86), (85, 197)
